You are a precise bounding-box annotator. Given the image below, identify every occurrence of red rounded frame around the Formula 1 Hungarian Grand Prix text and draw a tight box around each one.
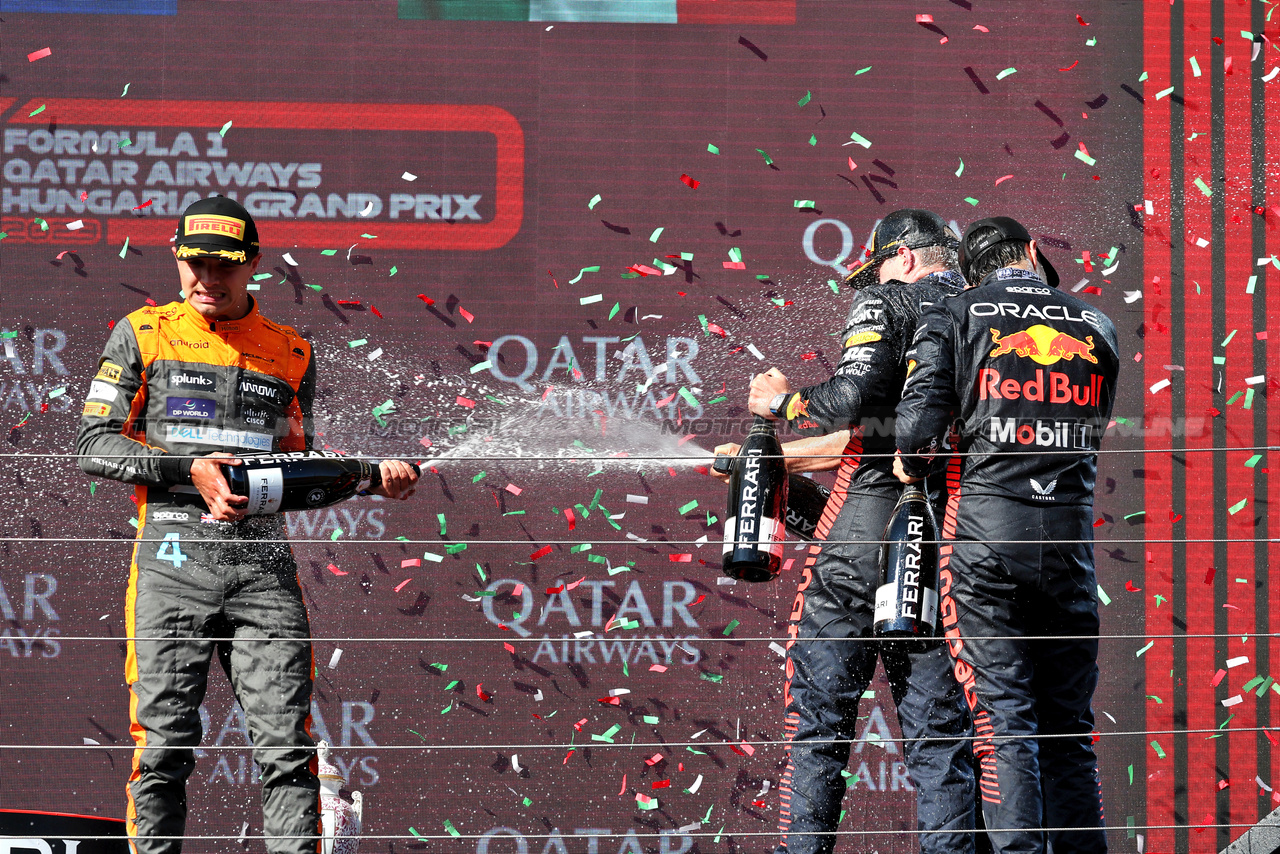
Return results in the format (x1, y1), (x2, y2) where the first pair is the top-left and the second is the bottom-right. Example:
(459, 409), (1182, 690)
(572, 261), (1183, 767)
(5, 99), (525, 251)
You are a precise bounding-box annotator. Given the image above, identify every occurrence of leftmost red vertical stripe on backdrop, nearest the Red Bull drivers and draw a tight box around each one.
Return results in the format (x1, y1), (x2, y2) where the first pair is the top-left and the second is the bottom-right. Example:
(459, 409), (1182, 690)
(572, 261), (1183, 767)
(1146, 0), (1178, 851)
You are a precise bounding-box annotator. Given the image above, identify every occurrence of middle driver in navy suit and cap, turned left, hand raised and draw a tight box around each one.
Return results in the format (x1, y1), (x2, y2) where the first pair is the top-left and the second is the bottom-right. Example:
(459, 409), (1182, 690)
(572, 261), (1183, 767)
(716, 209), (975, 854)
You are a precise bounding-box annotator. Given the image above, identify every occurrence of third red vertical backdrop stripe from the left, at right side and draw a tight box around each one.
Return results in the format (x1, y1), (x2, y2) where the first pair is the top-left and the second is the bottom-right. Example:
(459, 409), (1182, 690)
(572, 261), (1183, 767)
(1213, 3), (1271, 840)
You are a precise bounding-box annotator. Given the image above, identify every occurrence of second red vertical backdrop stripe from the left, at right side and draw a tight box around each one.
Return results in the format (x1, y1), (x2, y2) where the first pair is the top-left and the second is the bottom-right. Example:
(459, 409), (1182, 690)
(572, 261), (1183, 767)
(1161, 0), (1226, 829)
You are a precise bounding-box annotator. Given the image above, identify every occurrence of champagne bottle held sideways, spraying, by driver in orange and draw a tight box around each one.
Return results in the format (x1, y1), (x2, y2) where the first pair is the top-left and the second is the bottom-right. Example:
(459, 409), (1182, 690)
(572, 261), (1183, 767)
(223, 451), (419, 516)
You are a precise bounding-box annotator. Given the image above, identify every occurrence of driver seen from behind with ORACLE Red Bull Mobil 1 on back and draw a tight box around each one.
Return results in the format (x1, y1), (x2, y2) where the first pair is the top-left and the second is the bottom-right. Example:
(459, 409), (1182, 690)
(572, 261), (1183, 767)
(896, 216), (1119, 854)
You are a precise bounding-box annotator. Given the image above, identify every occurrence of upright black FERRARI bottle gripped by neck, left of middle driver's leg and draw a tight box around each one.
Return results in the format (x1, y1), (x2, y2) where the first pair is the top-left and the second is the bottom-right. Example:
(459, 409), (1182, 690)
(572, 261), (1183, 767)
(723, 416), (787, 581)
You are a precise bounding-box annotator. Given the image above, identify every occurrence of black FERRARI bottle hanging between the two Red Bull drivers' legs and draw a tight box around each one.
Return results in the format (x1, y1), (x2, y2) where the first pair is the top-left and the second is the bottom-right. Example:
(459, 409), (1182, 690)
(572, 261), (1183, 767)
(874, 484), (938, 638)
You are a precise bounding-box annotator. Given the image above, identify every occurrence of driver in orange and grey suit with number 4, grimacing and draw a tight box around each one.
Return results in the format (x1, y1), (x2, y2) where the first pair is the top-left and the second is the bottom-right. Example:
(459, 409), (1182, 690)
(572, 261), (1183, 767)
(77, 196), (416, 854)
